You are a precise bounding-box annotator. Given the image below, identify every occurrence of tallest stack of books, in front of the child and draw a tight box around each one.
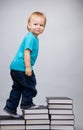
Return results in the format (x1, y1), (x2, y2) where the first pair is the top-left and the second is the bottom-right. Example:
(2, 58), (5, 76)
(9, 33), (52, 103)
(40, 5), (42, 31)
(46, 97), (74, 130)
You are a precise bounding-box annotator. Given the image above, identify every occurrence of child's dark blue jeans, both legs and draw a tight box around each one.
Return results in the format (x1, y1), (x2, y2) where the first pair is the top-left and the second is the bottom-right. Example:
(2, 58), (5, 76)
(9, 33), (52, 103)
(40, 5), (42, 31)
(6, 70), (37, 111)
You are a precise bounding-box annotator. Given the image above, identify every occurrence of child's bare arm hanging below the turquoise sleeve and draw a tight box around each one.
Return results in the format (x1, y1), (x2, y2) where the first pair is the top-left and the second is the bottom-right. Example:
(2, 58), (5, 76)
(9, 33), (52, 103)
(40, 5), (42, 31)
(24, 49), (32, 76)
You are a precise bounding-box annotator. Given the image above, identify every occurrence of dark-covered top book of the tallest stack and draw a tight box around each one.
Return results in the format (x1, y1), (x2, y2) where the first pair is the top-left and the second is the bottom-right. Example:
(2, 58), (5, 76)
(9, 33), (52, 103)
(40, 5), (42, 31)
(46, 97), (73, 104)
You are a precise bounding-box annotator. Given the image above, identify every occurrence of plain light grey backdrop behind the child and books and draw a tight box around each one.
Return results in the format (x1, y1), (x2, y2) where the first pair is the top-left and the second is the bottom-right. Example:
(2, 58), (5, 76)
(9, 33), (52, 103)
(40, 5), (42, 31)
(0, 0), (83, 130)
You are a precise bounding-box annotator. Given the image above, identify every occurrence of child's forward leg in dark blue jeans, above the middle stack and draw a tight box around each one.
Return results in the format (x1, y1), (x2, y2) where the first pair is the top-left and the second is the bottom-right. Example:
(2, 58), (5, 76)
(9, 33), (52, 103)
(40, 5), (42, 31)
(21, 71), (37, 109)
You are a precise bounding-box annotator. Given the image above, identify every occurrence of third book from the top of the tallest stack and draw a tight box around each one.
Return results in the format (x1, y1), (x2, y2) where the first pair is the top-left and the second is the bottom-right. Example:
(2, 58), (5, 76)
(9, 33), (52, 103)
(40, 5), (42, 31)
(49, 109), (73, 114)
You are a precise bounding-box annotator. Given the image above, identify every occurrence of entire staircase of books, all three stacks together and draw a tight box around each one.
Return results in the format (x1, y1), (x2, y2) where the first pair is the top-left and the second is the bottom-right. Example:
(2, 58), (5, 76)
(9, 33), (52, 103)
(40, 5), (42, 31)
(0, 97), (75, 130)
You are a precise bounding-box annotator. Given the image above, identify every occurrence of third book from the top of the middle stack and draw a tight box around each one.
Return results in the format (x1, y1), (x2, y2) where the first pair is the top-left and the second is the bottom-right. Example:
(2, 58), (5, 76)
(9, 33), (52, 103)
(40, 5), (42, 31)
(26, 119), (50, 125)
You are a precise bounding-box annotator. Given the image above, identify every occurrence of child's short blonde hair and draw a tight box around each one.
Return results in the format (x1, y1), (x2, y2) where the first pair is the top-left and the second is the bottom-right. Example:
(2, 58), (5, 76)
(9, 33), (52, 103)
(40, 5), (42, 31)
(27, 11), (46, 31)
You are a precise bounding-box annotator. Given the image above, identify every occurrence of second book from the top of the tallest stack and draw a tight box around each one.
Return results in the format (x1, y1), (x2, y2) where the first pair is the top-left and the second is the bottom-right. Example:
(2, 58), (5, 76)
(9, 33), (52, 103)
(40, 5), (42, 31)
(48, 103), (73, 109)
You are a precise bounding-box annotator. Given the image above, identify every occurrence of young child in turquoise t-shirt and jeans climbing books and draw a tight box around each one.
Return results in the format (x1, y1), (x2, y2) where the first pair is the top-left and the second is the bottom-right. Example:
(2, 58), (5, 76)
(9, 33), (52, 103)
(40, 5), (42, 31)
(4, 12), (46, 118)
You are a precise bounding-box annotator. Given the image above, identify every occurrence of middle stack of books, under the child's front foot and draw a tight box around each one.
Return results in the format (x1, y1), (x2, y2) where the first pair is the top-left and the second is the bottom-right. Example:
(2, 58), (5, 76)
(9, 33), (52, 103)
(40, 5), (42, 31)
(23, 106), (50, 130)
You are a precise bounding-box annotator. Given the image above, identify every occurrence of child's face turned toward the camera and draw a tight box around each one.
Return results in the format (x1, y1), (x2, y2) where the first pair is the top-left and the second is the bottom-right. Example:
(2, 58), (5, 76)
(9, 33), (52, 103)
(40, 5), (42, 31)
(28, 16), (45, 36)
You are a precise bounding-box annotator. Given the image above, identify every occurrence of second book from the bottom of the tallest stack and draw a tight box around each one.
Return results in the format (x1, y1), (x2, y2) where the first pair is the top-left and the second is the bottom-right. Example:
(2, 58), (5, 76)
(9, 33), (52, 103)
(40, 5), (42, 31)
(51, 120), (74, 125)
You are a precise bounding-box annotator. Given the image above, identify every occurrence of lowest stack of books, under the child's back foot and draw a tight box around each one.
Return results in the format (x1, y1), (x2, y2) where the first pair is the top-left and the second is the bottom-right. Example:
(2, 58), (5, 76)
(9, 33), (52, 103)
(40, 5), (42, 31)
(0, 116), (25, 130)
